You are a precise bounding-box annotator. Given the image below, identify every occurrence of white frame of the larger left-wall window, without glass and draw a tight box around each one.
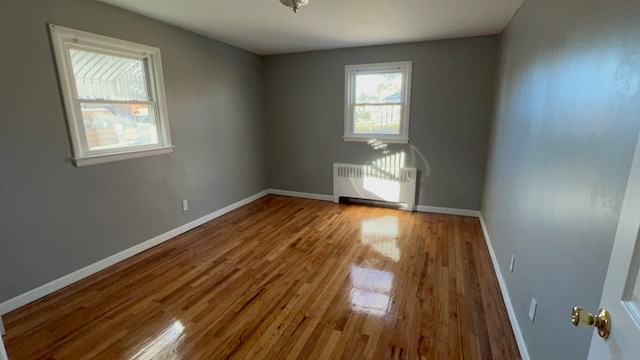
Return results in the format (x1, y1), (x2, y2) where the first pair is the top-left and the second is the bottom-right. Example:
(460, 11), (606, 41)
(49, 24), (173, 166)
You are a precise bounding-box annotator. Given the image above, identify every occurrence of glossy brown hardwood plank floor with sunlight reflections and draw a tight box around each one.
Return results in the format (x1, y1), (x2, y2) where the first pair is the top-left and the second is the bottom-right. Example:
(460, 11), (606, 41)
(3, 196), (520, 360)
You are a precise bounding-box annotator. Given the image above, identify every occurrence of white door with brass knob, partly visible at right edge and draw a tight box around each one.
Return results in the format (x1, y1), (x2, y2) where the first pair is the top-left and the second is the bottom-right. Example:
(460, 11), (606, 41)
(589, 129), (640, 360)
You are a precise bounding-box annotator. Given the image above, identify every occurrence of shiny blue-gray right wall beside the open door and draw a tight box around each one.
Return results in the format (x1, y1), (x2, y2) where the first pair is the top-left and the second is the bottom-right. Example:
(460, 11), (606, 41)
(482, 0), (640, 359)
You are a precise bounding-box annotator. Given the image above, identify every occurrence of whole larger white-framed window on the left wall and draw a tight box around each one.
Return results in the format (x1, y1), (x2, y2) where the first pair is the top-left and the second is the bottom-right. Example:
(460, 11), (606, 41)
(50, 25), (173, 166)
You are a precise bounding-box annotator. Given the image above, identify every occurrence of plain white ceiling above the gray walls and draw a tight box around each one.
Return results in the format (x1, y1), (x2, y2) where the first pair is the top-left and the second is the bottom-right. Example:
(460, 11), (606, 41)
(99, 0), (523, 55)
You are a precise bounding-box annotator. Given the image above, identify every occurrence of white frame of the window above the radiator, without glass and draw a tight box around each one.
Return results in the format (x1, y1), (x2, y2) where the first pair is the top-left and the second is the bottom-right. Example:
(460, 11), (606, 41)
(344, 61), (413, 144)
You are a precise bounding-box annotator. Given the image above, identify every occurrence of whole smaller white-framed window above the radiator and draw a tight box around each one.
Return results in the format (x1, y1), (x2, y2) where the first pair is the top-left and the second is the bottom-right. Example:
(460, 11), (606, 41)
(344, 61), (412, 144)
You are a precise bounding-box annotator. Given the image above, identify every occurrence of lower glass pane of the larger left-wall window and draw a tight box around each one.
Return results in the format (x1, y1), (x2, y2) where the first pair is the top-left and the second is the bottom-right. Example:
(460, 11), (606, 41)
(80, 103), (158, 150)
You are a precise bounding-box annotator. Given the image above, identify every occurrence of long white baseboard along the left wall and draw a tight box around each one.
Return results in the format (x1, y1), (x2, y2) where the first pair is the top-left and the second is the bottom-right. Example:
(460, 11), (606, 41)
(0, 190), (269, 316)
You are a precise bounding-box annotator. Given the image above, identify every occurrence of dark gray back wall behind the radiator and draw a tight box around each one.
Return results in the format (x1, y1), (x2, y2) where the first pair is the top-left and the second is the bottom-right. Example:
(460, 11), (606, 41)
(265, 36), (498, 210)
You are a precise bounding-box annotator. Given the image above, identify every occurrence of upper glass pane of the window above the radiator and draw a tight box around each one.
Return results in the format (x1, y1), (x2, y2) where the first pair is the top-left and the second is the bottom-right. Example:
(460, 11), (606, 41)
(355, 72), (402, 104)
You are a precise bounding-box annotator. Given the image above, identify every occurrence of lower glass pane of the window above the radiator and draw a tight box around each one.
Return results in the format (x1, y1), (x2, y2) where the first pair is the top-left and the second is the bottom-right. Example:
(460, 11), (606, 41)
(353, 104), (402, 135)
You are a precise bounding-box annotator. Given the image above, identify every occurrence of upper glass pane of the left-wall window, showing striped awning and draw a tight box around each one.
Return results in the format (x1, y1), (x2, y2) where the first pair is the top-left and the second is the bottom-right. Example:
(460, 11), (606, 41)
(69, 49), (149, 101)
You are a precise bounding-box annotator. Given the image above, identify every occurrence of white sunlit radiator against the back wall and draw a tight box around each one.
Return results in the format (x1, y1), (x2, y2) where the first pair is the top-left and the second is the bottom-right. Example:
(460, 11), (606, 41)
(333, 164), (418, 211)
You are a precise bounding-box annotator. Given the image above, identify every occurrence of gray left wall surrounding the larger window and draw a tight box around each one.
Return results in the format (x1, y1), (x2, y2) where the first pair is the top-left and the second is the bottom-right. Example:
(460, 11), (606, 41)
(0, 0), (267, 302)
